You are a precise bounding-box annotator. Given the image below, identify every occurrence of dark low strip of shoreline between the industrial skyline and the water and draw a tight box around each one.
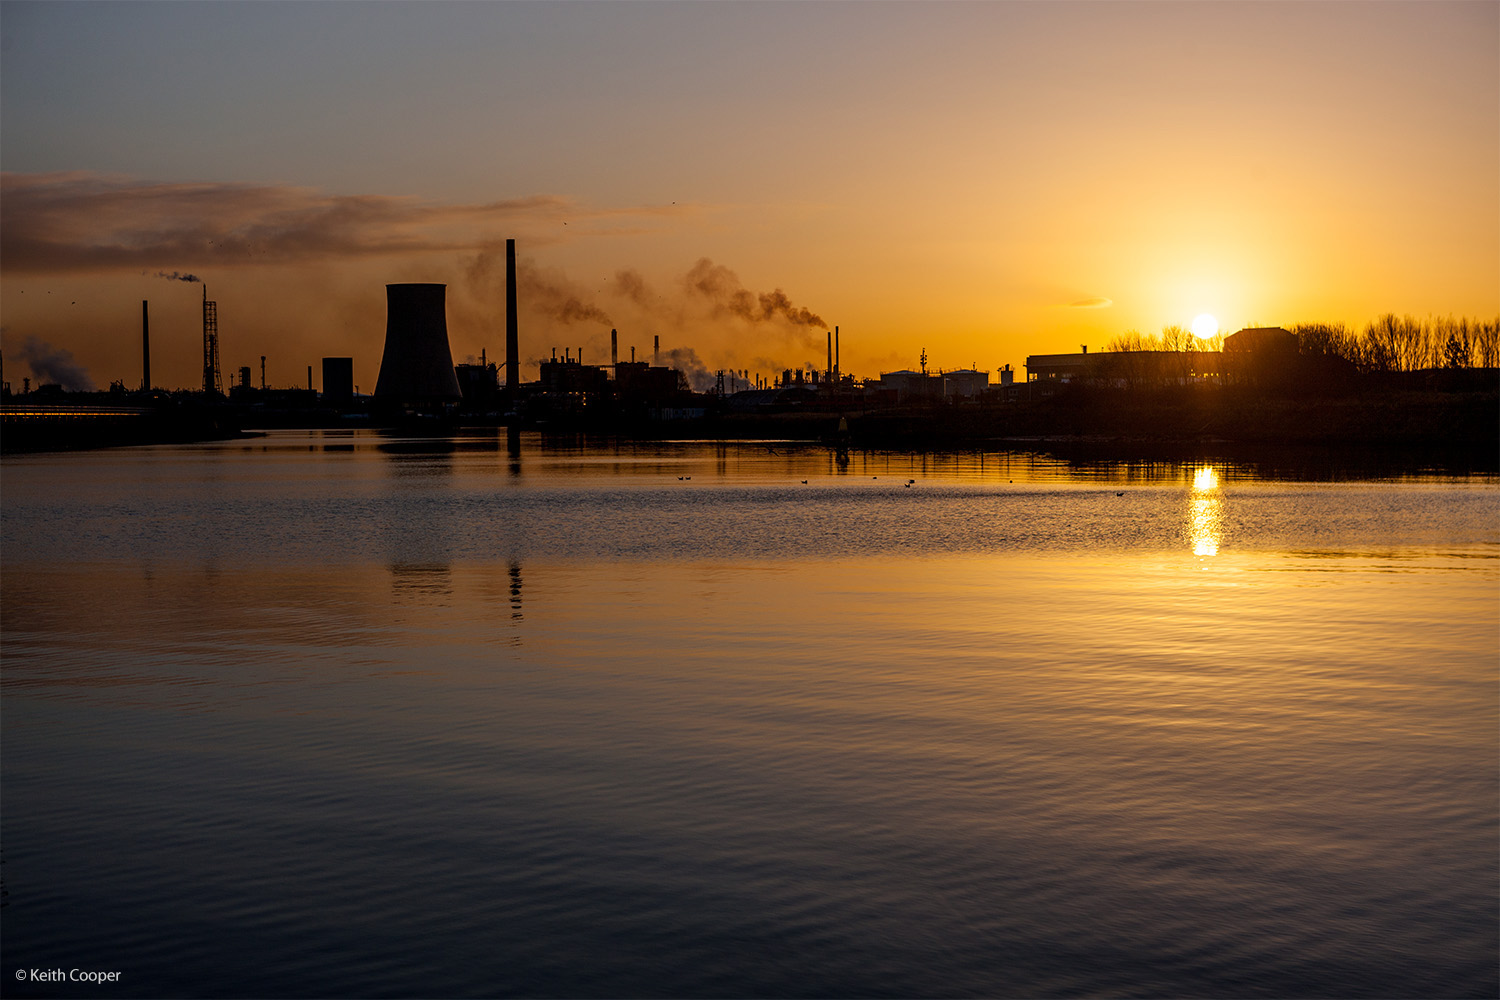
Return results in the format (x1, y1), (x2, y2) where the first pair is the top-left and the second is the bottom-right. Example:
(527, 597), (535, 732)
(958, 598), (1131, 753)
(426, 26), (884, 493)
(0, 379), (1500, 475)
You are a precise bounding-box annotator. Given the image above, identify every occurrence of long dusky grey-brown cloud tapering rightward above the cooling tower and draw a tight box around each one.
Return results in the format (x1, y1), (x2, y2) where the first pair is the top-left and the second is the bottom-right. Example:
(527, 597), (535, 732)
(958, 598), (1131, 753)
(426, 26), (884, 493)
(0, 172), (692, 273)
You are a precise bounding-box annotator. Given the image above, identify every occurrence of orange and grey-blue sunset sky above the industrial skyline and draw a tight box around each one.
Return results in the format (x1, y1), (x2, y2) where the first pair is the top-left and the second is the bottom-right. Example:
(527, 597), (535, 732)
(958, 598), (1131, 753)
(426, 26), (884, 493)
(0, 0), (1500, 391)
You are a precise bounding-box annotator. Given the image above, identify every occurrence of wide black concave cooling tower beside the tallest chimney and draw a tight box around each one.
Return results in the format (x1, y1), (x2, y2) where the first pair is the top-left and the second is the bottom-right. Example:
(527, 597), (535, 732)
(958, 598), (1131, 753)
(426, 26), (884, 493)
(375, 283), (464, 405)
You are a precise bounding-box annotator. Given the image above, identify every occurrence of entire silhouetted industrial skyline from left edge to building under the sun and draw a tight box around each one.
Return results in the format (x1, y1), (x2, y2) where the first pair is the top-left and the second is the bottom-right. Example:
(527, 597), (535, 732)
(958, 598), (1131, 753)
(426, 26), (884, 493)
(0, 240), (1493, 451)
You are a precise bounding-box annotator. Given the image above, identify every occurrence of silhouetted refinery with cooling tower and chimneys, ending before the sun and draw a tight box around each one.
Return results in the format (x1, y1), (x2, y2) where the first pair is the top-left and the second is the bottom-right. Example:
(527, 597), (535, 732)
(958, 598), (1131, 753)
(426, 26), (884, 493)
(6, 240), (1013, 426)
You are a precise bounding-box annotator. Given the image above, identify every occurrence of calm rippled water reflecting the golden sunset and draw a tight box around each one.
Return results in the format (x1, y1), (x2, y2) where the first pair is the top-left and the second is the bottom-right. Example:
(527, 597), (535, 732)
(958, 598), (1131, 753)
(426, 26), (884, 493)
(0, 432), (1500, 997)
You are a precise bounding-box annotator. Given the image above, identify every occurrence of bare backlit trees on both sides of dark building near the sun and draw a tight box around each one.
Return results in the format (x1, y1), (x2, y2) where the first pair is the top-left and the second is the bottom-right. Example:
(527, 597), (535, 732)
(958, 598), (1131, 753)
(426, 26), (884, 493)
(1104, 313), (1500, 372)
